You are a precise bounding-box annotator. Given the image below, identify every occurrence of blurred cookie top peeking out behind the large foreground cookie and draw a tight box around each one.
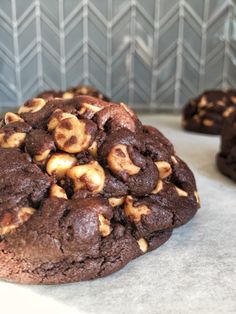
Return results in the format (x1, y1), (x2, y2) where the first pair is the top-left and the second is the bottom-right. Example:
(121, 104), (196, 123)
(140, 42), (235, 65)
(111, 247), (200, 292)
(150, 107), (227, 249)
(36, 85), (110, 101)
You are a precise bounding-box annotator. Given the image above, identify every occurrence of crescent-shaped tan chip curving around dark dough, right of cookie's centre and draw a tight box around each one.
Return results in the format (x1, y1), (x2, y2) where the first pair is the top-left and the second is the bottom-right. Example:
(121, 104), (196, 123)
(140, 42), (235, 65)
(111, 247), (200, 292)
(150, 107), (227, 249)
(107, 144), (140, 175)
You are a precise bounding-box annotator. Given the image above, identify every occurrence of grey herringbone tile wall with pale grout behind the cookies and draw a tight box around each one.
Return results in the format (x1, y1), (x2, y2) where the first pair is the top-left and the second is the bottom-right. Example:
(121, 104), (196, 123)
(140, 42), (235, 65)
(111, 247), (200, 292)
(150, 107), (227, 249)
(0, 0), (236, 110)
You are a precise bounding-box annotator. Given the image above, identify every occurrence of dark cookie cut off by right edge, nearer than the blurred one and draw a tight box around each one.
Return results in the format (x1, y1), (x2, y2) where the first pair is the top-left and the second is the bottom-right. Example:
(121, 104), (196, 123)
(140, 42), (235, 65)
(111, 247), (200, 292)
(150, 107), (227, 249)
(216, 106), (236, 181)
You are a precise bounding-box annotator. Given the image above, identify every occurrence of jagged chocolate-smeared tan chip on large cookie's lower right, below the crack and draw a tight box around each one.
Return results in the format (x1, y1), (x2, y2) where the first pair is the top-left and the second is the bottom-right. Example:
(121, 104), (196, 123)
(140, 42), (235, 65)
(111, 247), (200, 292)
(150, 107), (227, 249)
(124, 196), (151, 222)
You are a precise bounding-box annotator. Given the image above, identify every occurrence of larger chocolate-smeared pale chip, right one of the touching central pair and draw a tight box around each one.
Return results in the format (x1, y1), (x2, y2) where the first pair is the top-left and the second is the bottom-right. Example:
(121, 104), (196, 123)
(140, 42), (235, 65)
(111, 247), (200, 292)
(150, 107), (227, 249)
(67, 161), (105, 194)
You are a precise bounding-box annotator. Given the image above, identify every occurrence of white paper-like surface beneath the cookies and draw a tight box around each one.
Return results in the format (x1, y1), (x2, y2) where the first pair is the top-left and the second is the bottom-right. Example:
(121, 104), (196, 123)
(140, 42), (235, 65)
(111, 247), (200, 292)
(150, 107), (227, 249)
(0, 114), (236, 314)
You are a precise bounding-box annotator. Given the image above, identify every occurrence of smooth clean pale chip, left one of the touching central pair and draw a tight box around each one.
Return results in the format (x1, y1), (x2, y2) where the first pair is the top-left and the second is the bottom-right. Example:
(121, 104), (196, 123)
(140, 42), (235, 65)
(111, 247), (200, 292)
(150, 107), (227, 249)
(46, 153), (77, 179)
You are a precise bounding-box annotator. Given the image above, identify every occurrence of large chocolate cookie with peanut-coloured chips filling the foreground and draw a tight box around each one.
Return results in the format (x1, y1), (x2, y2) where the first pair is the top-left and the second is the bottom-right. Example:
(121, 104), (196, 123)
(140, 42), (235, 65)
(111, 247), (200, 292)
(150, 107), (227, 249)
(0, 96), (200, 284)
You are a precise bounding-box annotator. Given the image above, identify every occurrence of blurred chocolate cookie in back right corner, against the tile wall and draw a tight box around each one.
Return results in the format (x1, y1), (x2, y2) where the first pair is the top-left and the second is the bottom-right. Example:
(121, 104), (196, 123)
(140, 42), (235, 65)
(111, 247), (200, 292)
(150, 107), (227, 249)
(183, 90), (236, 134)
